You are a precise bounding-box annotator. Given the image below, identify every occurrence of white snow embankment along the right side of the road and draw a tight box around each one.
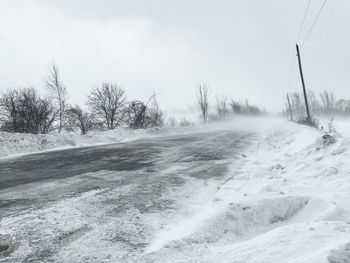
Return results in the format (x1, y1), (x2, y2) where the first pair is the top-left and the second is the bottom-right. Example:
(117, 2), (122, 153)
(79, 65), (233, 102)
(147, 122), (350, 263)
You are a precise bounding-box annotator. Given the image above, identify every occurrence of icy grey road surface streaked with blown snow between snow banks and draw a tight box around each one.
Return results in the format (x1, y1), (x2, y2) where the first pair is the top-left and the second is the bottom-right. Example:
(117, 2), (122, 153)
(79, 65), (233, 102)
(0, 130), (254, 262)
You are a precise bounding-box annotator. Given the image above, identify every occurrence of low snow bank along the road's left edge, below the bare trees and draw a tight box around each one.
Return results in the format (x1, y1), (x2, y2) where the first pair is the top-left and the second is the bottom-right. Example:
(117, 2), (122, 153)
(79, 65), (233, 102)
(0, 117), (292, 158)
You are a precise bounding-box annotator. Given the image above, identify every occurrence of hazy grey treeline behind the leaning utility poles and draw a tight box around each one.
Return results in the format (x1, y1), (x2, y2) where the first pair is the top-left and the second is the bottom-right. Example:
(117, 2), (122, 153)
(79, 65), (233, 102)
(284, 91), (350, 119)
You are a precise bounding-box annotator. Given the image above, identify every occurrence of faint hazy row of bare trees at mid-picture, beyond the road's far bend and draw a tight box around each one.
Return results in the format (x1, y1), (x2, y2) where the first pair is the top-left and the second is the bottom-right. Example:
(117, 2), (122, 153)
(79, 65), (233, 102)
(197, 85), (265, 122)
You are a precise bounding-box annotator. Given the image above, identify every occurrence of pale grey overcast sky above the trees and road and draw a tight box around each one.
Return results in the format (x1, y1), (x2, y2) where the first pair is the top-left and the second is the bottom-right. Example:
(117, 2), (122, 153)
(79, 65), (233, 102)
(0, 0), (350, 111)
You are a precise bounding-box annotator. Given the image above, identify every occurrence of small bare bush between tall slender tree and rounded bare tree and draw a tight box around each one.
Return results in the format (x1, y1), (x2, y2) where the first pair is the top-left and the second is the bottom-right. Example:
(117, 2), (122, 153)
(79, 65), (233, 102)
(67, 105), (96, 134)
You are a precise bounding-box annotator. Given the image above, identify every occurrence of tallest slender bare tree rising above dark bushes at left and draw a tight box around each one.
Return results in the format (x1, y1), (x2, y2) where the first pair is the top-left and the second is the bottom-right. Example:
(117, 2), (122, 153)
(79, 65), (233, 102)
(46, 63), (67, 133)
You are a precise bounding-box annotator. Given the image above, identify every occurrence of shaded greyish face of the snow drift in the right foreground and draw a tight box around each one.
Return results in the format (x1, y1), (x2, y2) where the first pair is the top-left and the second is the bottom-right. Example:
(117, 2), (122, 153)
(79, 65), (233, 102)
(180, 196), (308, 243)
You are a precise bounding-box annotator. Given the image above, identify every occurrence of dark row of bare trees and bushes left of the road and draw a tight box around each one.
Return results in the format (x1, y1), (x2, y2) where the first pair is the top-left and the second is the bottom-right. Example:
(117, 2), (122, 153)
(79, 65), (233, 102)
(0, 64), (164, 134)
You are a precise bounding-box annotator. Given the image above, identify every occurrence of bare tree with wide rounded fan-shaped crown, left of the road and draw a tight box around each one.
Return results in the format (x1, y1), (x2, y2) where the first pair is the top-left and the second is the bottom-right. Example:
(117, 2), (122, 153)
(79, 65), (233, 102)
(88, 83), (126, 130)
